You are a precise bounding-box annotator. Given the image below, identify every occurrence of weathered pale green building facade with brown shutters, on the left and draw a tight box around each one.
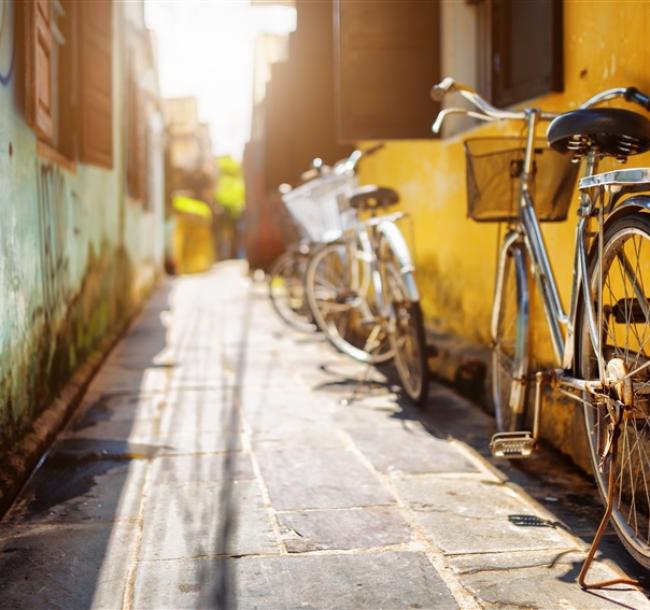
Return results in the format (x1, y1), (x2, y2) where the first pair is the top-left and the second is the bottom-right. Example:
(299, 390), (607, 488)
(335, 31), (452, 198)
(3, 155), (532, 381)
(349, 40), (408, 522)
(0, 0), (164, 504)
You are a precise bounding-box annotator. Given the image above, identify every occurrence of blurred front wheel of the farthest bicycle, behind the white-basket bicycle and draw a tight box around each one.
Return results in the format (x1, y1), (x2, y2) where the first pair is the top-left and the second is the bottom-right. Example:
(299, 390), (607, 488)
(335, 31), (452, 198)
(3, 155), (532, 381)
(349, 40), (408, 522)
(268, 252), (317, 332)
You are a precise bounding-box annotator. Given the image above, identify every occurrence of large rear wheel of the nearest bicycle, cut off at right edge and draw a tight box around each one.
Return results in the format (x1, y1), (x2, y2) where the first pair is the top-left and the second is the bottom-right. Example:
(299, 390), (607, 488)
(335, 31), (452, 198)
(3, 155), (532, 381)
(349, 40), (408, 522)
(576, 214), (650, 569)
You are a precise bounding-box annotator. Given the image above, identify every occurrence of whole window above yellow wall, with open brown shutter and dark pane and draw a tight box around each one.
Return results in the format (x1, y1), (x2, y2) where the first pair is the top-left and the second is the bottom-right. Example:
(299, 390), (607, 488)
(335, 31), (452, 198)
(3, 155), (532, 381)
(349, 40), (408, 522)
(335, 0), (563, 141)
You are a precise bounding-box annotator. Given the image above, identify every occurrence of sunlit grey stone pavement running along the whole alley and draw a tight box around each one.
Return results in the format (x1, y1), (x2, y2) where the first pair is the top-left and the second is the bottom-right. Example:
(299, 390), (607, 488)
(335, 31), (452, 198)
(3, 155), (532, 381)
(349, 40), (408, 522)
(0, 262), (650, 610)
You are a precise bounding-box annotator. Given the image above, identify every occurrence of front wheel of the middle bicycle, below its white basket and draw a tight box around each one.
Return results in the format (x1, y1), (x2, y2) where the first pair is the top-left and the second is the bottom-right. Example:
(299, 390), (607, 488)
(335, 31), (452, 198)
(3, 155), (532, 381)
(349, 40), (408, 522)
(305, 242), (392, 363)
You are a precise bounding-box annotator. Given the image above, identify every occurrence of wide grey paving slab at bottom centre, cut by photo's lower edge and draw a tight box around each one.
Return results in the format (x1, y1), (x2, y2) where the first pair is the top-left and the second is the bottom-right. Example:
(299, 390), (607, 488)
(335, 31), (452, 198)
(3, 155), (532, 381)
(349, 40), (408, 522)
(134, 552), (458, 610)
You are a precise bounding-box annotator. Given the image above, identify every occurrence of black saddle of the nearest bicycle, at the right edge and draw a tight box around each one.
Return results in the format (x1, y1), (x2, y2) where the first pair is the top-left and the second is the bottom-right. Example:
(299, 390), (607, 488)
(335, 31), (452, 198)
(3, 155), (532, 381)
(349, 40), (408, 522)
(546, 108), (650, 158)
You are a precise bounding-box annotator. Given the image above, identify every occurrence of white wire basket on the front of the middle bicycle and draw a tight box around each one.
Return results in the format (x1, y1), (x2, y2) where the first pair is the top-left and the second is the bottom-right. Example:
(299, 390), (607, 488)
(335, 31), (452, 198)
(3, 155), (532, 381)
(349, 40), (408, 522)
(282, 173), (357, 243)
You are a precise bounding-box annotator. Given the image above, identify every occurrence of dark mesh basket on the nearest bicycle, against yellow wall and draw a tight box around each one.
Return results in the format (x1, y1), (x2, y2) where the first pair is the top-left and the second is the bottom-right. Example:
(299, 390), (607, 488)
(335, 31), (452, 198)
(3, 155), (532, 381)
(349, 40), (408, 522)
(465, 137), (578, 222)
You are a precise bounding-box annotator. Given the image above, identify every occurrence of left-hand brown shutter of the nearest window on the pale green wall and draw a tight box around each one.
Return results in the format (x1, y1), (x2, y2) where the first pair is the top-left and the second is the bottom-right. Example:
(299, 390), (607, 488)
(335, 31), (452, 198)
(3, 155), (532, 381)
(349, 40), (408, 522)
(24, 0), (54, 142)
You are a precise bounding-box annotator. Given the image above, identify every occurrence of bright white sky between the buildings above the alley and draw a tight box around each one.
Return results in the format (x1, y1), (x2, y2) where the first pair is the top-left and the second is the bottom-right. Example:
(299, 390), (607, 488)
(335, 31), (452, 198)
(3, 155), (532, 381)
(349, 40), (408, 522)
(145, 0), (295, 158)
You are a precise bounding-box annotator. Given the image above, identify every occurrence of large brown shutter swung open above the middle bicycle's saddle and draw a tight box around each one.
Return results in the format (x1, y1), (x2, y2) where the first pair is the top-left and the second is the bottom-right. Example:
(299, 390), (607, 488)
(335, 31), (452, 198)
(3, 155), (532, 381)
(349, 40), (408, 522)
(334, 0), (440, 142)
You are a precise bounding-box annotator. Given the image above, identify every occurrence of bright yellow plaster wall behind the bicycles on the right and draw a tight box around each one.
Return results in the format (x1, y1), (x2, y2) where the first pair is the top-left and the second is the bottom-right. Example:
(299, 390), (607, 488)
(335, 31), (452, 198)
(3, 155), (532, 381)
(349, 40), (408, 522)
(360, 0), (650, 360)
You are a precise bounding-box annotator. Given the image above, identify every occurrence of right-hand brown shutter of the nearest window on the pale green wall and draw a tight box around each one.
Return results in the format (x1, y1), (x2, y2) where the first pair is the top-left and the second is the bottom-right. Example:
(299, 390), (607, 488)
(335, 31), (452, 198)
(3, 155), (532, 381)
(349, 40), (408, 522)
(79, 0), (113, 168)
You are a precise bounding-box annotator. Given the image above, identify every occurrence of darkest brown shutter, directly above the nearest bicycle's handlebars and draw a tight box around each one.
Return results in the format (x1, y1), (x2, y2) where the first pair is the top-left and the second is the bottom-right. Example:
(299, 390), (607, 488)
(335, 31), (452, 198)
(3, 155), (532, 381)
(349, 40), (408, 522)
(490, 0), (563, 107)
